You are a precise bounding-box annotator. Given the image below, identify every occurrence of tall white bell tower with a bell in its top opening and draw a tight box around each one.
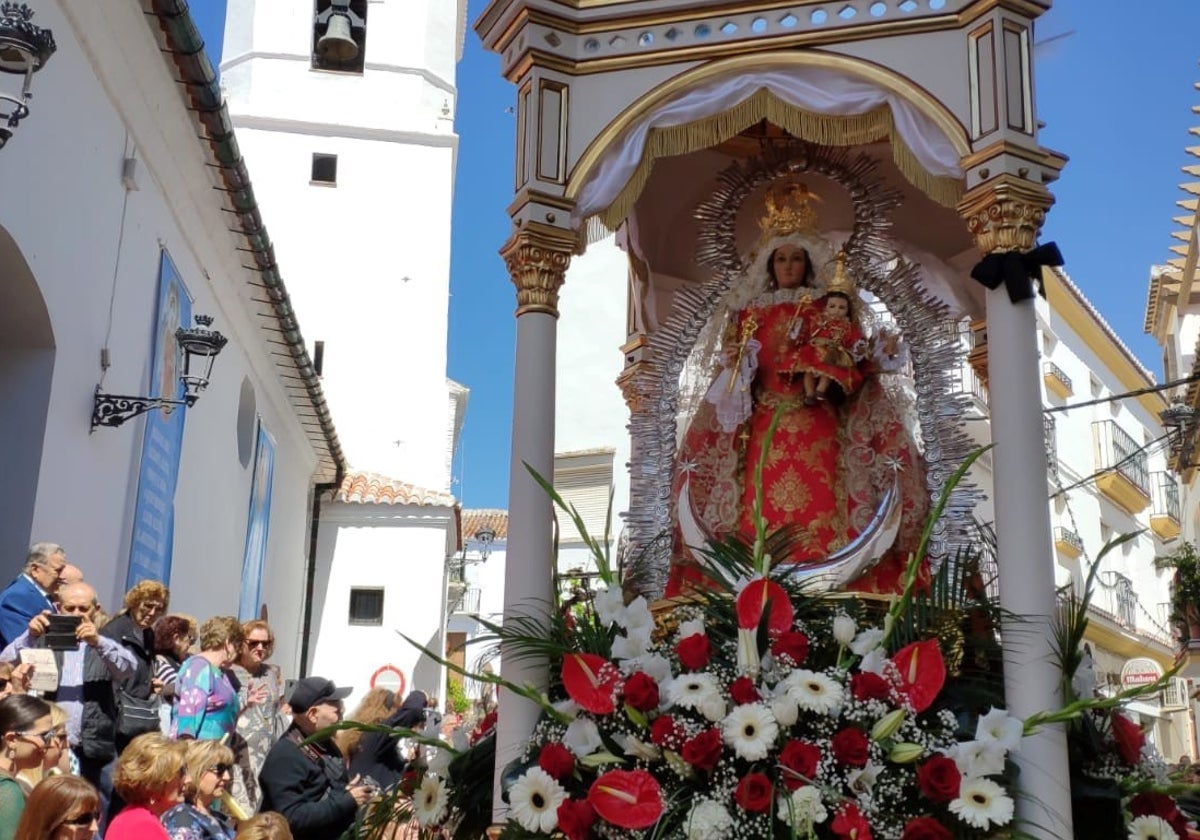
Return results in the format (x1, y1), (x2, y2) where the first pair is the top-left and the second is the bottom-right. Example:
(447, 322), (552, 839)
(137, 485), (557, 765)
(221, 0), (466, 491)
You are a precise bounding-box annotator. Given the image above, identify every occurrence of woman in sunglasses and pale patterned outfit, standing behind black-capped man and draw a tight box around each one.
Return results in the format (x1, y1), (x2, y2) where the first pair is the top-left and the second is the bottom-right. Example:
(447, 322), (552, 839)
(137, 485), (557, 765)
(232, 618), (292, 814)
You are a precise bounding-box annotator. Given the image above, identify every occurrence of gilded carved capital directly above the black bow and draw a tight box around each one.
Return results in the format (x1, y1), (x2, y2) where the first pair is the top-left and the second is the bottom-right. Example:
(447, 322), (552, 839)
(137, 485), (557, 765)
(958, 175), (1054, 256)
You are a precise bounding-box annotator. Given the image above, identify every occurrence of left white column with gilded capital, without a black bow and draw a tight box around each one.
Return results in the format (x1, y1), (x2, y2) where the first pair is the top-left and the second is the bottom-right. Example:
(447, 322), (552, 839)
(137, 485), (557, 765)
(492, 222), (576, 823)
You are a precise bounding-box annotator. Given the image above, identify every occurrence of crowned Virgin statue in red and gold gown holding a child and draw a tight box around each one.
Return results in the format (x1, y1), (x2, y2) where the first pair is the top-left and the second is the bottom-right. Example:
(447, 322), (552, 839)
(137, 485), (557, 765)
(666, 180), (928, 596)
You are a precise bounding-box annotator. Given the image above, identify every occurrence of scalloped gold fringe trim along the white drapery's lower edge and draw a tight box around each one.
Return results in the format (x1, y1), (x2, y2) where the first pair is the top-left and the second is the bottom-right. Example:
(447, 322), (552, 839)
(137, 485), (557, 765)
(588, 88), (962, 232)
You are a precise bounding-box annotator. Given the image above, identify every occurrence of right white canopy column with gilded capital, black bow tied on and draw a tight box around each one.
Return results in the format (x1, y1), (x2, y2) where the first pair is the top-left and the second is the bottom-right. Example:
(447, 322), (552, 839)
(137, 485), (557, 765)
(959, 175), (1072, 840)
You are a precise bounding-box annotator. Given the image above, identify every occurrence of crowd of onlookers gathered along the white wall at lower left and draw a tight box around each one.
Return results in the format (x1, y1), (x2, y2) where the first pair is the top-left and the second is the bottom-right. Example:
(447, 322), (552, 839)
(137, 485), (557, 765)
(0, 542), (451, 840)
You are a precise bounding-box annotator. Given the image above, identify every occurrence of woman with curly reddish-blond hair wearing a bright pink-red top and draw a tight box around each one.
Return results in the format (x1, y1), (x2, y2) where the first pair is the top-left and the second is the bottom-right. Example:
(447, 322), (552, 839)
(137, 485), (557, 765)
(104, 732), (192, 840)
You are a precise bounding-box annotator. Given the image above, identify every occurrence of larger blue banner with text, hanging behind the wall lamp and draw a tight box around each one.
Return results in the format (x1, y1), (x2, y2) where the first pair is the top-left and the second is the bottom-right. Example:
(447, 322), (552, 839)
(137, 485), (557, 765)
(125, 250), (192, 589)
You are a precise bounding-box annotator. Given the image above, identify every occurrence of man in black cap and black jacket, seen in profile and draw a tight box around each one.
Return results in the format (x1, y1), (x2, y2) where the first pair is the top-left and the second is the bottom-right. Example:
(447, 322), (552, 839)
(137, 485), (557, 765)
(258, 677), (376, 840)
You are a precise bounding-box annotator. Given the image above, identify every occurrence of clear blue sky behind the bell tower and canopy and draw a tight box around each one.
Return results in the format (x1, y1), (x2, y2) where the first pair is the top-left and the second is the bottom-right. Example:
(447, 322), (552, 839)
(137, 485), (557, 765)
(192, 0), (1200, 508)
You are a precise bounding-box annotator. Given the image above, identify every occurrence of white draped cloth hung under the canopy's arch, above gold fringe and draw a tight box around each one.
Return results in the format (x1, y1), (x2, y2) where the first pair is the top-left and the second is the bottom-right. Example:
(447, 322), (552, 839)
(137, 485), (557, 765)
(571, 66), (962, 227)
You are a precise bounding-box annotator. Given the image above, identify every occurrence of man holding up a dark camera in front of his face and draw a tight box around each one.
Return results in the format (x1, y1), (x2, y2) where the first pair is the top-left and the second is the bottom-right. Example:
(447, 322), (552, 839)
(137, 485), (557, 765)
(0, 582), (137, 757)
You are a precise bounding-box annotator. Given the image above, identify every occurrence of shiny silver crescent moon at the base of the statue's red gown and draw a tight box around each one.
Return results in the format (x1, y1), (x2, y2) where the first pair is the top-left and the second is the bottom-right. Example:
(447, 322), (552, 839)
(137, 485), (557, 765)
(677, 468), (902, 593)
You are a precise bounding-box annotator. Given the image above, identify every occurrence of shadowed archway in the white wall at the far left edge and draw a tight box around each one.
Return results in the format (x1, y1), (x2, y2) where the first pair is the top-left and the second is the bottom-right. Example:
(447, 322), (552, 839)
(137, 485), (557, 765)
(0, 227), (55, 576)
